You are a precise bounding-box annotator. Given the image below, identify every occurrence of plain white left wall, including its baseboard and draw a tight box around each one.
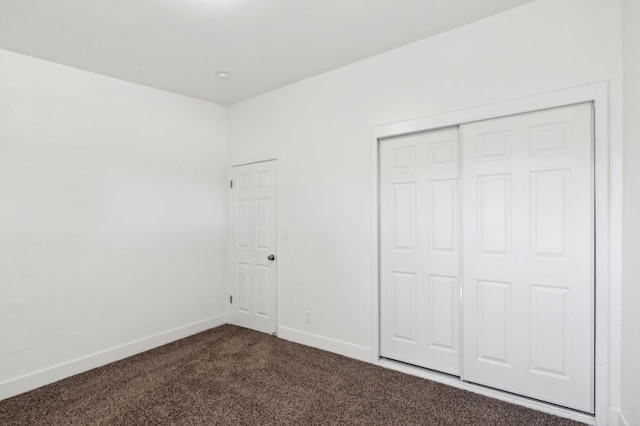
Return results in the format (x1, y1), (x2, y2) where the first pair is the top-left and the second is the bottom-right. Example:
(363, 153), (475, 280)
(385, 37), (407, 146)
(0, 51), (227, 399)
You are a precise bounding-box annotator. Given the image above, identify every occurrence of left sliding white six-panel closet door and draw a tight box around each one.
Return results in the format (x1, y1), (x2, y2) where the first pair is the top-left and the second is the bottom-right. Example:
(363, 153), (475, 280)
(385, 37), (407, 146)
(380, 128), (460, 375)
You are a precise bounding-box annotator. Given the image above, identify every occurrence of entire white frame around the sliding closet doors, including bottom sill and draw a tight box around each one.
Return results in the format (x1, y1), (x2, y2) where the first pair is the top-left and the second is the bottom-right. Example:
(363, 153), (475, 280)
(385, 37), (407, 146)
(370, 81), (622, 425)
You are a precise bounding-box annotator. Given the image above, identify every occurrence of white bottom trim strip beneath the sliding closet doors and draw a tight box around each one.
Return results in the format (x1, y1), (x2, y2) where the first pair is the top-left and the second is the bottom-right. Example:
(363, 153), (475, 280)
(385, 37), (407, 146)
(377, 359), (596, 425)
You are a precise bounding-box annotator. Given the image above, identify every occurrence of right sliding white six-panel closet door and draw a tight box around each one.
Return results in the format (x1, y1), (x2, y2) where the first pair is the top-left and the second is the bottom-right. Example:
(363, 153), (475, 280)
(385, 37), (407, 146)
(461, 104), (594, 413)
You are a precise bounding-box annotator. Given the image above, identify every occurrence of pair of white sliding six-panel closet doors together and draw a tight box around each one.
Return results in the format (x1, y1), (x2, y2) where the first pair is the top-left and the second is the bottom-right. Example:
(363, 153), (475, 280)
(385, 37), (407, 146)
(379, 103), (595, 413)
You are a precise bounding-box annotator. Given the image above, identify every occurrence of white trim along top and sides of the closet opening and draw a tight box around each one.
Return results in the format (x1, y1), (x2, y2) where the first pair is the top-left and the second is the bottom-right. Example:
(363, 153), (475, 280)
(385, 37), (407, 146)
(370, 81), (622, 425)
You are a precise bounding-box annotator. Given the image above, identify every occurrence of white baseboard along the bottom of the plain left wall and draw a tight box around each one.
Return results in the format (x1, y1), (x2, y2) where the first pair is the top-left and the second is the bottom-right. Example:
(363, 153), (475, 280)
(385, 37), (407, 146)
(0, 314), (227, 400)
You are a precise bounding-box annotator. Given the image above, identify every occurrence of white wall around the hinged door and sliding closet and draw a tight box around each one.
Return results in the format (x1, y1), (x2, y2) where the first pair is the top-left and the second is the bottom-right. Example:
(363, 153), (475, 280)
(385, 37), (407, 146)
(229, 0), (624, 412)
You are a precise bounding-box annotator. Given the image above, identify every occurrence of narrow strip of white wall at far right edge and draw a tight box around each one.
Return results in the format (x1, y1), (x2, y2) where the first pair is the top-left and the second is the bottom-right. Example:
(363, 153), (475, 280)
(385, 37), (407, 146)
(621, 0), (640, 425)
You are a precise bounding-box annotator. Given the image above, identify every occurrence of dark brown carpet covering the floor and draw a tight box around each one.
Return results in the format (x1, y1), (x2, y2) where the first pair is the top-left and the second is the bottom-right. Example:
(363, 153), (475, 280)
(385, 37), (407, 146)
(0, 325), (579, 426)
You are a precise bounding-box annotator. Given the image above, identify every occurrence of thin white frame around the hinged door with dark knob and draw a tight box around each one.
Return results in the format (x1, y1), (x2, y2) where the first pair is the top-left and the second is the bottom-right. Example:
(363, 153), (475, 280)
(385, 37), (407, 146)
(225, 157), (281, 336)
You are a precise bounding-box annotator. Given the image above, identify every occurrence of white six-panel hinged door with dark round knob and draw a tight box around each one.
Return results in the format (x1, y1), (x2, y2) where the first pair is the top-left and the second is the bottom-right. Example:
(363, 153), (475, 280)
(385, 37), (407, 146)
(229, 161), (277, 333)
